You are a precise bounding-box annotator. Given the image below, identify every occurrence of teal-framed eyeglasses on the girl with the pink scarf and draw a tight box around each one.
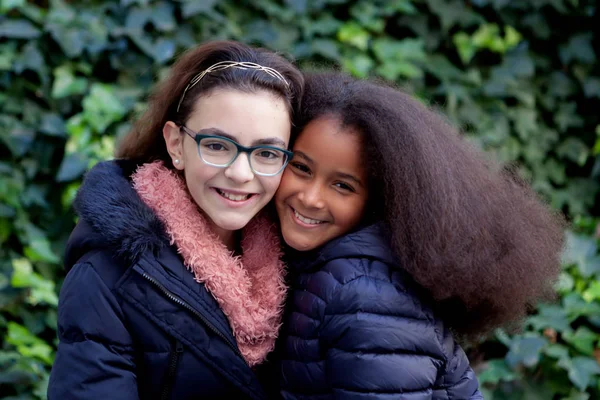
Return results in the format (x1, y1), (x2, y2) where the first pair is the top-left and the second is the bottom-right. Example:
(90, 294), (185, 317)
(179, 125), (294, 176)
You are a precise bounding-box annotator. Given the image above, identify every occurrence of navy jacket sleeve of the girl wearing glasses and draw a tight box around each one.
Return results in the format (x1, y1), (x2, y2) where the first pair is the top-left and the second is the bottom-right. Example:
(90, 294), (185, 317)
(48, 263), (139, 400)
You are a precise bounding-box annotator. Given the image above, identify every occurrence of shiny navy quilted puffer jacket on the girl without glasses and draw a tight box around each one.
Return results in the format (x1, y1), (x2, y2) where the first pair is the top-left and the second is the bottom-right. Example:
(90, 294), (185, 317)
(278, 224), (483, 400)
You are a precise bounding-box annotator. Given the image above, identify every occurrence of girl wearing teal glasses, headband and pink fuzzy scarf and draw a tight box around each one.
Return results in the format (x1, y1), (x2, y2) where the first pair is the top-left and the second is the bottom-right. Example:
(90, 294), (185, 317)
(48, 42), (303, 400)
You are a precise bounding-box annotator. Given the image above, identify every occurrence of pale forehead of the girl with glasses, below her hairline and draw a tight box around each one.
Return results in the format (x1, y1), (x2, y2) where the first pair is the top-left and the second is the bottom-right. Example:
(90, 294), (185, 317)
(186, 89), (291, 146)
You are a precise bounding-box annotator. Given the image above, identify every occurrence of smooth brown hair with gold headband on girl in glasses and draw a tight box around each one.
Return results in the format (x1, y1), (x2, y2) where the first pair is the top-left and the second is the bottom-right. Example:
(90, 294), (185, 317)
(115, 41), (304, 166)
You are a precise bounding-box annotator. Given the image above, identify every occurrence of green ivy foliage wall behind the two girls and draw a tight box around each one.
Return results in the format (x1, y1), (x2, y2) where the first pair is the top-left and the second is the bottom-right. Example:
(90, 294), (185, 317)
(0, 0), (600, 400)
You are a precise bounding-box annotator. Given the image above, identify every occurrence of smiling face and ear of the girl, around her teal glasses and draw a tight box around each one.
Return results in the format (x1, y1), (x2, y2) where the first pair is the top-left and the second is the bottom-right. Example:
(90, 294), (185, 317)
(163, 89), (291, 241)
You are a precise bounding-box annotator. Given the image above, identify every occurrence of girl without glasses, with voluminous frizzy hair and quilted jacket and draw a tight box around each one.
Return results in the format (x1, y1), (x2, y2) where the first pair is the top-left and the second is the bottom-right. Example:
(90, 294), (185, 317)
(275, 74), (563, 399)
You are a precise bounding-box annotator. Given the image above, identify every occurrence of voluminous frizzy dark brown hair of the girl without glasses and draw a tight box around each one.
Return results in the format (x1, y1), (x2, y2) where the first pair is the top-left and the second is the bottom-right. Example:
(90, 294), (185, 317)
(297, 73), (565, 338)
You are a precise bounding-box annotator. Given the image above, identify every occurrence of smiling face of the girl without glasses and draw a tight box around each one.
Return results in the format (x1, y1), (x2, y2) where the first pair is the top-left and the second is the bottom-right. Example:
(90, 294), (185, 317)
(275, 117), (368, 251)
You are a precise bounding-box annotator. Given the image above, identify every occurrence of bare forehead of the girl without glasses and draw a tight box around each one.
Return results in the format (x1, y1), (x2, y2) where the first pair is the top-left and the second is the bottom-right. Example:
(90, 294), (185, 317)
(294, 117), (365, 178)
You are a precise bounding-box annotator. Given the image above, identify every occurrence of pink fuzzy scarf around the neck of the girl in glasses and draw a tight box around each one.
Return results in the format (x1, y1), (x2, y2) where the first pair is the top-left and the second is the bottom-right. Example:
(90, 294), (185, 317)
(132, 161), (286, 366)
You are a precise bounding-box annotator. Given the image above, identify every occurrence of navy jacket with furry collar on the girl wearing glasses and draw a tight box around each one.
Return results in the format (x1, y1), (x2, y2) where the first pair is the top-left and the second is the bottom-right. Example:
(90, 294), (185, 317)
(48, 161), (266, 400)
